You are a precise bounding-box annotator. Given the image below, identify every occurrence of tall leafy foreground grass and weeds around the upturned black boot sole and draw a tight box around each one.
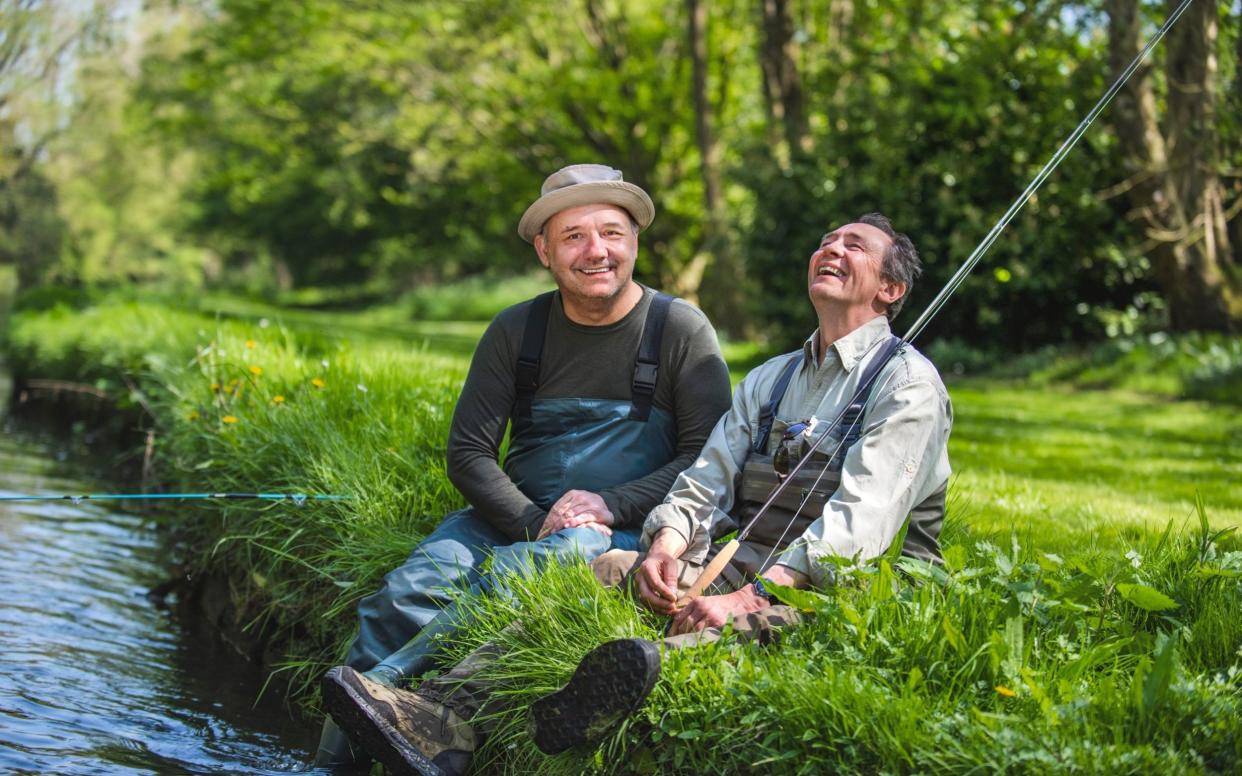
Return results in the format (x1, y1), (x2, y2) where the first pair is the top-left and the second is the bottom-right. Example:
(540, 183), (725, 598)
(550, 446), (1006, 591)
(446, 529), (1242, 774)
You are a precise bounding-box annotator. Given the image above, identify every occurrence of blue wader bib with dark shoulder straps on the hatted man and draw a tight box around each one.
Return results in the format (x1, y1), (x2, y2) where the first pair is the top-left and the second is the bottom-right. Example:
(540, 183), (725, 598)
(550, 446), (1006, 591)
(503, 292), (677, 509)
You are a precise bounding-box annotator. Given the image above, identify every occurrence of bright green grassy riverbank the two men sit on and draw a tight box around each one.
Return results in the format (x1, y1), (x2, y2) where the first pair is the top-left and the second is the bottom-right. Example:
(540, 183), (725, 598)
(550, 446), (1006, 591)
(7, 293), (1242, 772)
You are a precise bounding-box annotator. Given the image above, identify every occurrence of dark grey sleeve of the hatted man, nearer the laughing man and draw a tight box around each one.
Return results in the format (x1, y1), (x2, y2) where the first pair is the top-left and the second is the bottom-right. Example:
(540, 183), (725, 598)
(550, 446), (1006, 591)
(600, 312), (729, 528)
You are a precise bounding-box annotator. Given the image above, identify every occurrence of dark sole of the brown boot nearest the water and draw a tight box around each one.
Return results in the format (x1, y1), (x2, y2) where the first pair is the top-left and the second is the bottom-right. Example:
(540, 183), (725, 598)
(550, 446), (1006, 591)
(320, 665), (445, 776)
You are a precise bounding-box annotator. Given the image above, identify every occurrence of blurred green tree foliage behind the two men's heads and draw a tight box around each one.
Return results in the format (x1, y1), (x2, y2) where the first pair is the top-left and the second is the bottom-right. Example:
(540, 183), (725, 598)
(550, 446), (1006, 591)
(9, 0), (1242, 342)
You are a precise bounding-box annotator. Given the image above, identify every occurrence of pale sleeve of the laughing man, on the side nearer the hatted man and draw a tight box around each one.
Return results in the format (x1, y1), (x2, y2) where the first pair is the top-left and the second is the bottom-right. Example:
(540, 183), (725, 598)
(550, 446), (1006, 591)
(642, 362), (760, 564)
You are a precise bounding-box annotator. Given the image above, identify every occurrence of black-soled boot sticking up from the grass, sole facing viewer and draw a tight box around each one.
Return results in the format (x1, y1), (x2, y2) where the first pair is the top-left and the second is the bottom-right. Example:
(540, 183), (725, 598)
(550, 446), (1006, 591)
(528, 638), (660, 755)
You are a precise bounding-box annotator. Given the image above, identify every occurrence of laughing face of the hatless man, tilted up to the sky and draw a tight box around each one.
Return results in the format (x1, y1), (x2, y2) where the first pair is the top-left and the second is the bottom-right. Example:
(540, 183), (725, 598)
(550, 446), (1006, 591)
(807, 223), (905, 324)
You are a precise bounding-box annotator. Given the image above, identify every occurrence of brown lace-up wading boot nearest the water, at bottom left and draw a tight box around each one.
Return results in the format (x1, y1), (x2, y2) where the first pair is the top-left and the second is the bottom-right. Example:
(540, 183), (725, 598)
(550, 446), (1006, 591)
(322, 665), (476, 776)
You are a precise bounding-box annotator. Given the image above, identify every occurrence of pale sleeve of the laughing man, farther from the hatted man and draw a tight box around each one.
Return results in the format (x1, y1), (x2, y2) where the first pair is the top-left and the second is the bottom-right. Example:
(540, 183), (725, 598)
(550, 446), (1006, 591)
(776, 369), (953, 587)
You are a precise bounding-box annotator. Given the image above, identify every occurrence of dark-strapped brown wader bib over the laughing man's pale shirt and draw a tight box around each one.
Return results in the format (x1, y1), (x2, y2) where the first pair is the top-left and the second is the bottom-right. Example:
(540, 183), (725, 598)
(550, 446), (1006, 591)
(713, 336), (946, 586)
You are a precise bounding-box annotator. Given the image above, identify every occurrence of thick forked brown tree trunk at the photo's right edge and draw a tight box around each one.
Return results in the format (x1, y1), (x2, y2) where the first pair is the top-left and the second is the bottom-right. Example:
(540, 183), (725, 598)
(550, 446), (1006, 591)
(1107, 0), (1242, 332)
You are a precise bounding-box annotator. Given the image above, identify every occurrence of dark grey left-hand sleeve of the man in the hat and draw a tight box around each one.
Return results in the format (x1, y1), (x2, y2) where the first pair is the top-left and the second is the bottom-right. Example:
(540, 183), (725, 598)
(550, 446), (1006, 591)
(447, 312), (548, 541)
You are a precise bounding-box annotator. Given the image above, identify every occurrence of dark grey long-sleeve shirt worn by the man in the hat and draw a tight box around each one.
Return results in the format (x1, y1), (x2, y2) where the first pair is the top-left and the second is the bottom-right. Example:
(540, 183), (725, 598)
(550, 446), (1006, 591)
(448, 288), (729, 541)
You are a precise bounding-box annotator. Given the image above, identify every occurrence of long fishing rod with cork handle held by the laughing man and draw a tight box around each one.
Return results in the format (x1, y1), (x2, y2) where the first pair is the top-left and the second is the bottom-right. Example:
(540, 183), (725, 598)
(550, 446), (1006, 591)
(677, 0), (1194, 608)
